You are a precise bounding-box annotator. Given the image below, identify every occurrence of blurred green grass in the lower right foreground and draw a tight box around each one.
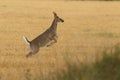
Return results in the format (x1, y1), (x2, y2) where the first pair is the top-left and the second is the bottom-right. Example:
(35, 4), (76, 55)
(25, 45), (120, 80)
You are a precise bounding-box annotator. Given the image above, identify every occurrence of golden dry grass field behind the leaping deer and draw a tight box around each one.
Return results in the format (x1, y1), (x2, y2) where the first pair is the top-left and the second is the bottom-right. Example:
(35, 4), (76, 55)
(0, 0), (120, 80)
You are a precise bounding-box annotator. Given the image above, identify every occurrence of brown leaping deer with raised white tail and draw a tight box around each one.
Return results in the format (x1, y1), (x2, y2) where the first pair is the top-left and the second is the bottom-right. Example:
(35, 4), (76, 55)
(23, 12), (64, 57)
